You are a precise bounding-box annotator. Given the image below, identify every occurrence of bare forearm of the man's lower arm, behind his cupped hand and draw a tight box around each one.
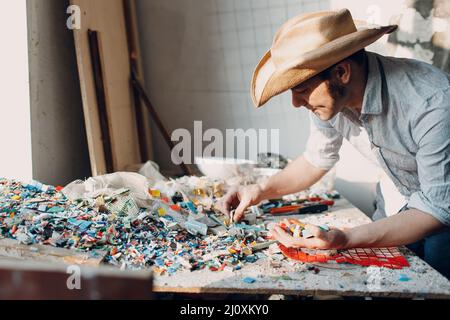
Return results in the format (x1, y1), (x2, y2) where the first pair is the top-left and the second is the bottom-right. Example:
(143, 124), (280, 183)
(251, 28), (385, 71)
(342, 209), (444, 249)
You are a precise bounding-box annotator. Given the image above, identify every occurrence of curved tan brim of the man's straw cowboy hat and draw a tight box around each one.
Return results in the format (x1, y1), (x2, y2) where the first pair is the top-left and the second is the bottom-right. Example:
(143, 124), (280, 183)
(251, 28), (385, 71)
(251, 25), (397, 108)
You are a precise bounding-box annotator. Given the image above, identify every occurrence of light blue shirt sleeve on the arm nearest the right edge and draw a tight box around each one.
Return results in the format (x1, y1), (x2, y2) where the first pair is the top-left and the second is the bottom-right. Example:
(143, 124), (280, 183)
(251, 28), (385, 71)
(408, 90), (450, 226)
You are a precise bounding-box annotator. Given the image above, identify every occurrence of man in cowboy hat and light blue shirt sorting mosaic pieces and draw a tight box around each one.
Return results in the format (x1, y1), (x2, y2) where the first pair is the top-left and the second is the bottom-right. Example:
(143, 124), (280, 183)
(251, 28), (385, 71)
(218, 10), (450, 277)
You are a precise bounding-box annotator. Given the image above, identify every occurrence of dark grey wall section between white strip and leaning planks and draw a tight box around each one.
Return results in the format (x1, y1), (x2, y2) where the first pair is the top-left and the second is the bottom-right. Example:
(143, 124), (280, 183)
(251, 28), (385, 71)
(27, 0), (90, 185)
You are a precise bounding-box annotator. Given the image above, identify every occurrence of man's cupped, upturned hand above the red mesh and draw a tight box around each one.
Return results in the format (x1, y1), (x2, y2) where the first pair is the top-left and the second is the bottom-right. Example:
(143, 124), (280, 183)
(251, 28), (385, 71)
(270, 225), (348, 250)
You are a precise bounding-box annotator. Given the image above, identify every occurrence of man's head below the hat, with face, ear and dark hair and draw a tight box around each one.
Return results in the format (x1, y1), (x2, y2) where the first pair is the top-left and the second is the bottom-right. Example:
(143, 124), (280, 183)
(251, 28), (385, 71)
(291, 50), (367, 121)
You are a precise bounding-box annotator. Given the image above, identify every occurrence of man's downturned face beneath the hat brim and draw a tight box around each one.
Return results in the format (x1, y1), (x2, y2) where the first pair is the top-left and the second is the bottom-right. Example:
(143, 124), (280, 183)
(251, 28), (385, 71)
(291, 76), (345, 121)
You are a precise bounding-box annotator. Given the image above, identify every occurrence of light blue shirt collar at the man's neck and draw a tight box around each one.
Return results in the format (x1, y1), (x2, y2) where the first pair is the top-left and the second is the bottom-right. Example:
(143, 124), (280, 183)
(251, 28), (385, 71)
(361, 52), (382, 115)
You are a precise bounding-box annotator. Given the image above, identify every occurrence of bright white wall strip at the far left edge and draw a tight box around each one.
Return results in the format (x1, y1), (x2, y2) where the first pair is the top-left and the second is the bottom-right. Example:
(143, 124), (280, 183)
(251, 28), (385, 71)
(0, 0), (32, 180)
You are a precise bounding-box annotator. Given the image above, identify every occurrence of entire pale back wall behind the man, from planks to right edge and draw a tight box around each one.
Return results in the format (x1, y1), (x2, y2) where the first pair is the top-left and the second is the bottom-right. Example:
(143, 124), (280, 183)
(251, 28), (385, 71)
(137, 0), (450, 215)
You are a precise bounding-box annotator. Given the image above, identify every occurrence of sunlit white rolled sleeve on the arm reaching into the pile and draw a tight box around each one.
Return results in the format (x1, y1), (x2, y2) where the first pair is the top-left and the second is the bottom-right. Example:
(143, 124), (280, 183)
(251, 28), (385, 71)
(303, 112), (343, 170)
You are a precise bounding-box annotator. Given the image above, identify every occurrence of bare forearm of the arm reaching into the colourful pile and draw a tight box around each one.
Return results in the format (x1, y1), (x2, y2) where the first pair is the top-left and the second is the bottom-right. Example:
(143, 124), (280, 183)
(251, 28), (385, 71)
(261, 156), (327, 199)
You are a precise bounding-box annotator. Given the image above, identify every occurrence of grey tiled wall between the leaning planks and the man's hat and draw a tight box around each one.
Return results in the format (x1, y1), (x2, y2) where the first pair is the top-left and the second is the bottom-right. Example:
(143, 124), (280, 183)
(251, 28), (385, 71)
(137, 0), (329, 168)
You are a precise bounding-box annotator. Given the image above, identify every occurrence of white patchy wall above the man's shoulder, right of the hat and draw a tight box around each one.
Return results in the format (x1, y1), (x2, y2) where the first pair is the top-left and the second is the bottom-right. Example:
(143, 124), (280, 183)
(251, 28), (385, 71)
(331, 0), (450, 72)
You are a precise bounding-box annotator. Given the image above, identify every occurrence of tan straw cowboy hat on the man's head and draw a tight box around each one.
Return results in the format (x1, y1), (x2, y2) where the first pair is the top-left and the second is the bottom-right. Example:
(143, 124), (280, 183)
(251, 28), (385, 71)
(251, 9), (397, 107)
